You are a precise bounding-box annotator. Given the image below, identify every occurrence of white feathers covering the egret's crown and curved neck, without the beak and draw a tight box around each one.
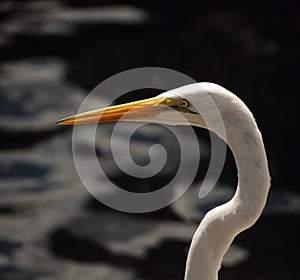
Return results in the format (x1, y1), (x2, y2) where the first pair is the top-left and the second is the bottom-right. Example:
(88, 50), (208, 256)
(161, 83), (270, 280)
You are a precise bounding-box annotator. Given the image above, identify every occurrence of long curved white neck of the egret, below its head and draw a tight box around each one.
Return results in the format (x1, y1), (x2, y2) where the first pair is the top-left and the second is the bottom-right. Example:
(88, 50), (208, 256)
(184, 95), (270, 280)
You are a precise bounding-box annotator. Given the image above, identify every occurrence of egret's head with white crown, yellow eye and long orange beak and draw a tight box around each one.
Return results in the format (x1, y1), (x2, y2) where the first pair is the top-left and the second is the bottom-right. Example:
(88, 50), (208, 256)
(57, 83), (231, 128)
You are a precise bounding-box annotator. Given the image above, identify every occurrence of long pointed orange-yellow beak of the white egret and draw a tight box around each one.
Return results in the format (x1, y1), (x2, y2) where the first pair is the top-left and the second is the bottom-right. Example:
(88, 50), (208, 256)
(56, 97), (178, 125)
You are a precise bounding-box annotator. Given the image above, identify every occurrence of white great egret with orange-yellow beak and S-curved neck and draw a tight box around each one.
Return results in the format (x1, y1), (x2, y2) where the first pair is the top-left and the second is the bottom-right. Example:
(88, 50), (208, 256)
(57, 83), (270, 280)
